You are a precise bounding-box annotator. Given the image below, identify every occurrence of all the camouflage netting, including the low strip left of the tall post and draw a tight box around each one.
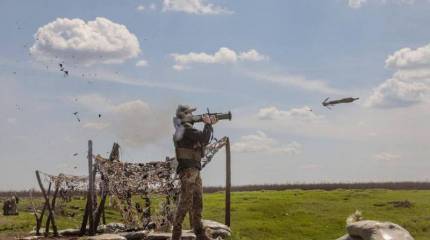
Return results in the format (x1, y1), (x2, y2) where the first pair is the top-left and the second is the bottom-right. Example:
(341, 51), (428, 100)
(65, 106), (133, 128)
(36, 137), (227, 231)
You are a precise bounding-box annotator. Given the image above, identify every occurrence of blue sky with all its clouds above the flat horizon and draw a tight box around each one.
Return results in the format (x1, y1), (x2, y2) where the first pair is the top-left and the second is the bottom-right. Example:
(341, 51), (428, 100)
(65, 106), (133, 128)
(0, 0), (430, 190)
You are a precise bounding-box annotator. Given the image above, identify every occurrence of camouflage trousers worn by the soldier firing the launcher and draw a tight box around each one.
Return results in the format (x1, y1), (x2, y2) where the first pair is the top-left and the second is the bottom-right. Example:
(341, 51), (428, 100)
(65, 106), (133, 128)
(172, 168), (207, 240)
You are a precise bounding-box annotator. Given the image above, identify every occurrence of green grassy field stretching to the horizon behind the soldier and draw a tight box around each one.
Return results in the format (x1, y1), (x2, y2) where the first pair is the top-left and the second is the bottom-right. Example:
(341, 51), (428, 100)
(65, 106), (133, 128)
(0, 189), (430, 240)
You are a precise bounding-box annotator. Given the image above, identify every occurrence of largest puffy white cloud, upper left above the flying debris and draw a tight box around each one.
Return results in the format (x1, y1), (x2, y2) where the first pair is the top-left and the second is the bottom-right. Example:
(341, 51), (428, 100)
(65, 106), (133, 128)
(30, 17), (140, 65)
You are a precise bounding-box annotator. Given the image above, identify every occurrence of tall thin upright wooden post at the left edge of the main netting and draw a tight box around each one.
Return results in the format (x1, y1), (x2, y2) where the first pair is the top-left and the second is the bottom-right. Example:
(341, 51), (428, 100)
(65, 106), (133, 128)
(87, 140), (95, 236)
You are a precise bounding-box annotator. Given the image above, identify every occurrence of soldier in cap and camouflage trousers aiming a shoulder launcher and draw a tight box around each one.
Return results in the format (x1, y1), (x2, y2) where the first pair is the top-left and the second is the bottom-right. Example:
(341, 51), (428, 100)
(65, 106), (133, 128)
(172, 105), (217, 240)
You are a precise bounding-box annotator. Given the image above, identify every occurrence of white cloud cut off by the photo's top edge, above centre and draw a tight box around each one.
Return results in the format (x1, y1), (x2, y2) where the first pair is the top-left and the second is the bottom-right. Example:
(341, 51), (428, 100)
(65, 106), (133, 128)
(163, 0), (233, 15)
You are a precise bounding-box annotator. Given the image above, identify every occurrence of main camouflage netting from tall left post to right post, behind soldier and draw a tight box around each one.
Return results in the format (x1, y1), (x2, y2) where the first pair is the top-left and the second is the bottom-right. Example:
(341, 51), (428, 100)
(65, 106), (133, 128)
(95, 137), (227, 231)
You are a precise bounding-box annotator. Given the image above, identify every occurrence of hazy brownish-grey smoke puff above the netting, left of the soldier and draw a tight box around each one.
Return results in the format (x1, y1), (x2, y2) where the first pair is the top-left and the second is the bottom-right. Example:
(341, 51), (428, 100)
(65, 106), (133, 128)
(77, 94), (171, 147)
